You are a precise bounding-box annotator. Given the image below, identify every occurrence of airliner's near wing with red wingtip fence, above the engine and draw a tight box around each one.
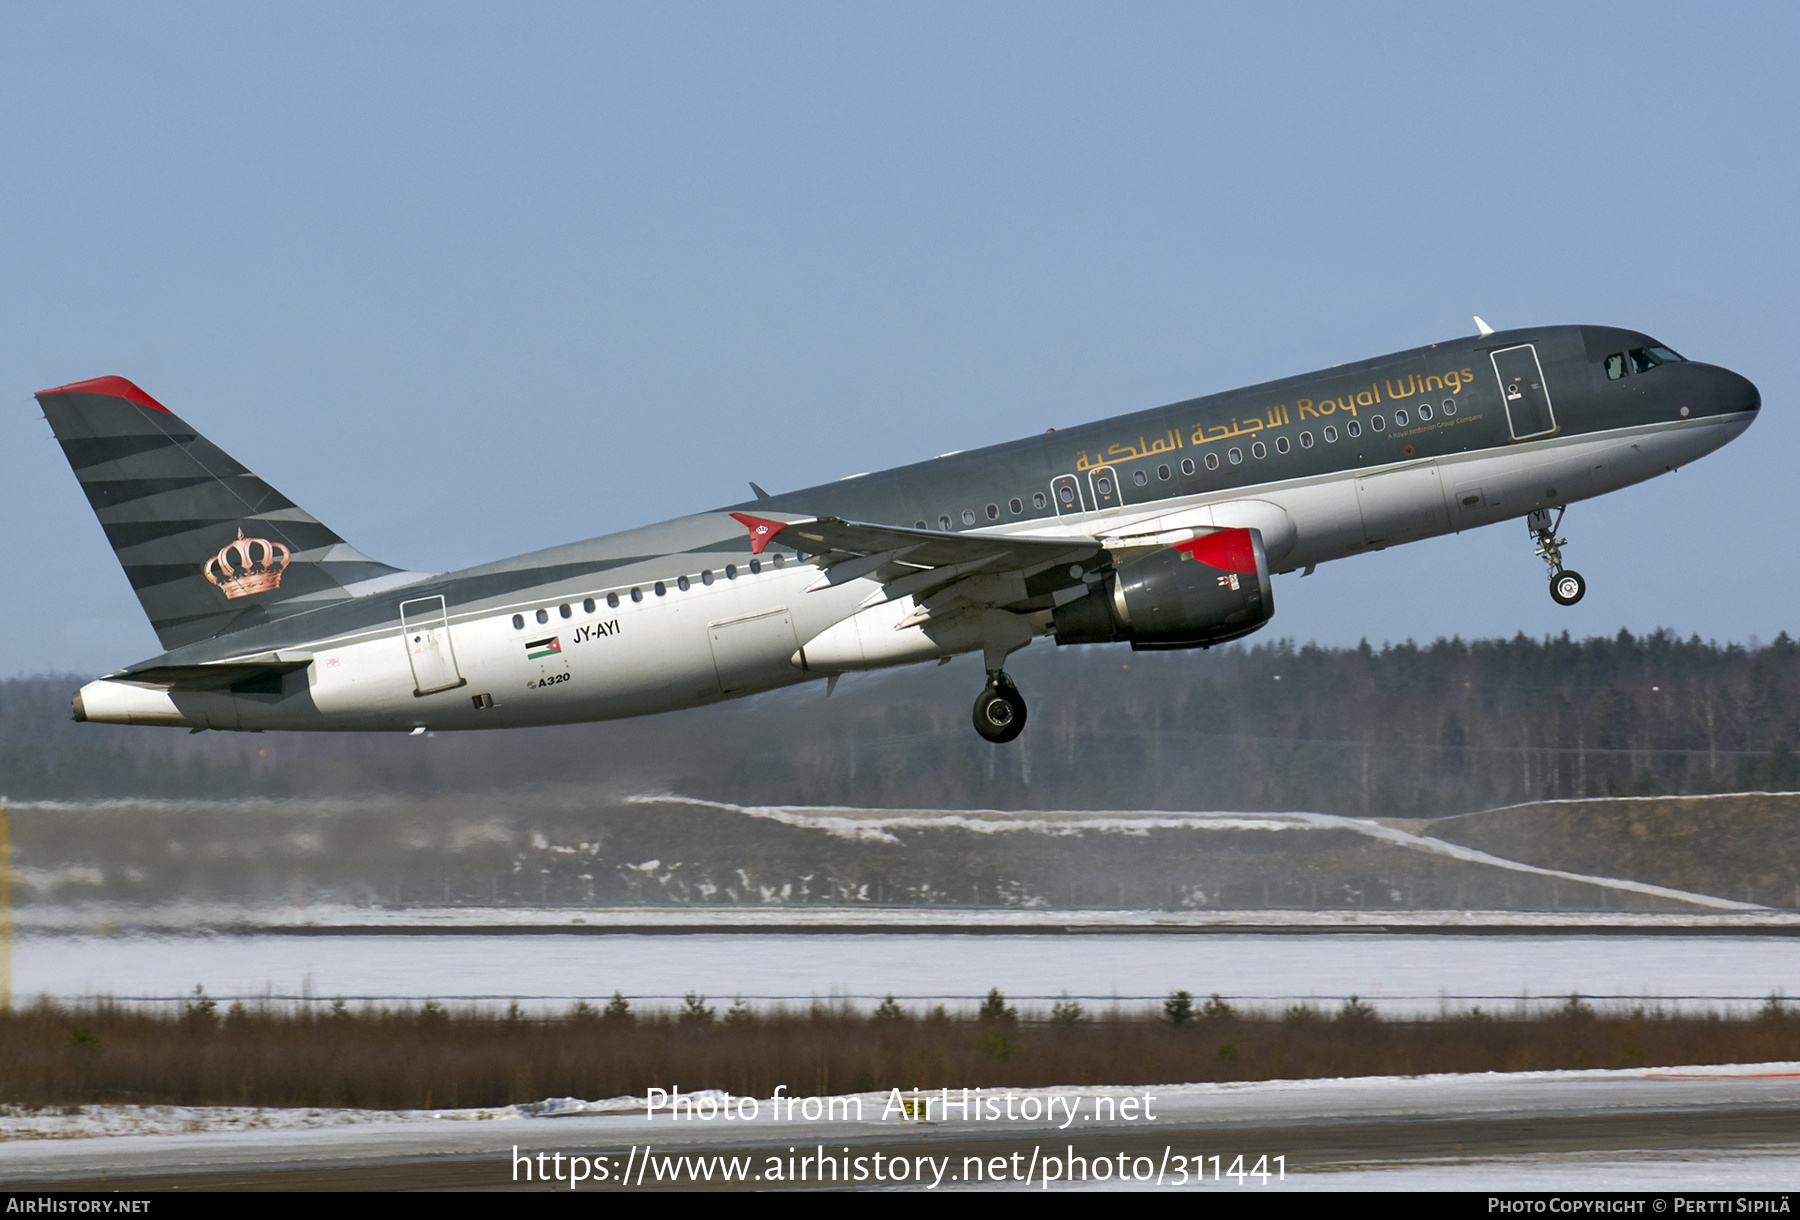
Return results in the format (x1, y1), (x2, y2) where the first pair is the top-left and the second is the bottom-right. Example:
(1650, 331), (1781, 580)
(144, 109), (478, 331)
(731, 513), (1105, 612)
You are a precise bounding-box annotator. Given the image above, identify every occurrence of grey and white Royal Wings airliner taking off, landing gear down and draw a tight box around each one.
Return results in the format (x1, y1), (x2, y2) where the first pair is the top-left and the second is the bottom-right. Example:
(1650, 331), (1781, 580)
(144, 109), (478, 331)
(38, 318), (1762, 741)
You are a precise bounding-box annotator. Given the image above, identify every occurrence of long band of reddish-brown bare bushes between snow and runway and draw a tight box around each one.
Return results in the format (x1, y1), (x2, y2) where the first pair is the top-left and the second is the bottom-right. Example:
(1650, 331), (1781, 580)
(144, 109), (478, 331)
(0, 997), (1800, 1108)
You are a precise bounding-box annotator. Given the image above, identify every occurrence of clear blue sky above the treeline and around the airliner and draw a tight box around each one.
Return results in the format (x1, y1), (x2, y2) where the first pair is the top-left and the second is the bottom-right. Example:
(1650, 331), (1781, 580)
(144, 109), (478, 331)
(0, 4), (1800, 675)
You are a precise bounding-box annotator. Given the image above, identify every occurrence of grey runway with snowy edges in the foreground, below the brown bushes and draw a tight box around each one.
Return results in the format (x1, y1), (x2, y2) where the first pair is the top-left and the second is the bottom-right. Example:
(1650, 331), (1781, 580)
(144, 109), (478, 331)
(0, 1063), (1800, 1191)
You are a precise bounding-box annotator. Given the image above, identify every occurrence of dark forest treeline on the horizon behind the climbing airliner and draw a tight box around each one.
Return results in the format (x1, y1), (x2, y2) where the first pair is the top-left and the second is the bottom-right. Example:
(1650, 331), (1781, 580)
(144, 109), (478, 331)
(0, 630), (1800, 817)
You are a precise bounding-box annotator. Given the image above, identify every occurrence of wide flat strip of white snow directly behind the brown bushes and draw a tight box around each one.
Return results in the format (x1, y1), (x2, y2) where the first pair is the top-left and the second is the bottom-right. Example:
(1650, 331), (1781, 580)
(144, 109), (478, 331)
(13, 916), (1800, 1017)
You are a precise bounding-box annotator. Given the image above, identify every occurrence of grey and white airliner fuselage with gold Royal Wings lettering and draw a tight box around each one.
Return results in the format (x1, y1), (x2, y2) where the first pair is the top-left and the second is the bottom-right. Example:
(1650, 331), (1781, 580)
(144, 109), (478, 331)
(47, 326), (1760, 731)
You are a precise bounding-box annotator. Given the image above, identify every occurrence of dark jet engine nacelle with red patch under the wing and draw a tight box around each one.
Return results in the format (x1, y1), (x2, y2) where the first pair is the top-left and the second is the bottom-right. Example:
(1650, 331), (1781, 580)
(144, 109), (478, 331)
(1057, 529), (1274, 650)
